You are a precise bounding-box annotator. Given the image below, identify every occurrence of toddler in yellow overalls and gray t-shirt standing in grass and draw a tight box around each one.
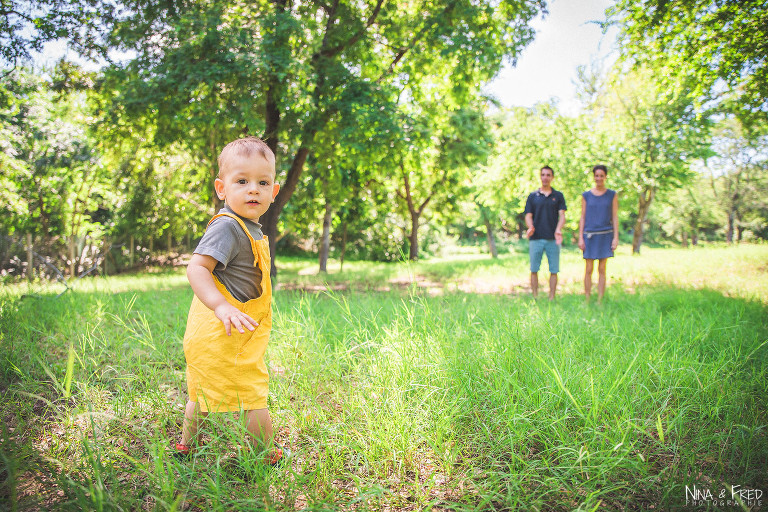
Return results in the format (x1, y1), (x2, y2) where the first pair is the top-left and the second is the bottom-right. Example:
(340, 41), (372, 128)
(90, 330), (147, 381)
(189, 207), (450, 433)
(176, 137), (288, 465)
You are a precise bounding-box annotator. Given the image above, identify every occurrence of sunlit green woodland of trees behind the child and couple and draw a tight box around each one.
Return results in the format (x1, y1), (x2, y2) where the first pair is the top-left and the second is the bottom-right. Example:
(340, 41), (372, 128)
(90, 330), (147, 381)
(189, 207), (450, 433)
(0, 0), (768, 280)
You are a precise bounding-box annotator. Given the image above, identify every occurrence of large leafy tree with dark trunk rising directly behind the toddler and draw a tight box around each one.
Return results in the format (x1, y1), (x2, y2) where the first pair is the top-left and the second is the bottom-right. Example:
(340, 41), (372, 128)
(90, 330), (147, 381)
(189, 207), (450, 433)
(100, 0), (544, 273)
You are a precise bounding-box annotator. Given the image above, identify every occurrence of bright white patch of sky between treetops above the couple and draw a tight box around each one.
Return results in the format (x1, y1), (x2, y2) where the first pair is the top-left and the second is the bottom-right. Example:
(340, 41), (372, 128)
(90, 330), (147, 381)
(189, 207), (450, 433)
(484, 0), (617, 115)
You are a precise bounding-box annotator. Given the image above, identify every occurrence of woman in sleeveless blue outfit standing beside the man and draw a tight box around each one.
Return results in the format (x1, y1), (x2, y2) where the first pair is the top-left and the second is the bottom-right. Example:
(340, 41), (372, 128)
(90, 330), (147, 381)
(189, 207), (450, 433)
(579, 165), (619, 302)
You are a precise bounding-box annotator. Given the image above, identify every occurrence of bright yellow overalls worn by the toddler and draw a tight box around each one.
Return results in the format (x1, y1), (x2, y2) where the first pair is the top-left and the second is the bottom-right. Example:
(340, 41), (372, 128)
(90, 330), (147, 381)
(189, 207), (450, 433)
(184, 213), (272, 412)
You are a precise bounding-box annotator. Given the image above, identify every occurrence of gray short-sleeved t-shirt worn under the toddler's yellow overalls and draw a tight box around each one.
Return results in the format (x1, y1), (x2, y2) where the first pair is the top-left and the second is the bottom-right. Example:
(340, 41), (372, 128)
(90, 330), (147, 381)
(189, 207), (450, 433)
(195, 206), (264, 302)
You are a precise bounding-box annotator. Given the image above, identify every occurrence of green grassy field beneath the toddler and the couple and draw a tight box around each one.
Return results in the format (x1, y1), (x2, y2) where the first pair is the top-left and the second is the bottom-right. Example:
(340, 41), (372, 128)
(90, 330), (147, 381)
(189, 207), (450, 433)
(0, 245), (768, 511)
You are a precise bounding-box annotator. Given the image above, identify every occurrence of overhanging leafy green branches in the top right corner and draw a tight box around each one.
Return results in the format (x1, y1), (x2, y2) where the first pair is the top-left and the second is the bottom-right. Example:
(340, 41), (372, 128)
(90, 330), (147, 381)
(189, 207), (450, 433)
(609, 0), (768, 123)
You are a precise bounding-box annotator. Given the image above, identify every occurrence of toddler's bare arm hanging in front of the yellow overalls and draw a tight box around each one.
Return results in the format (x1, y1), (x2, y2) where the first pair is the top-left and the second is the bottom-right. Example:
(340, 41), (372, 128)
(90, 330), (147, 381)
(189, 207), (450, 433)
(187, 254), (259, 336)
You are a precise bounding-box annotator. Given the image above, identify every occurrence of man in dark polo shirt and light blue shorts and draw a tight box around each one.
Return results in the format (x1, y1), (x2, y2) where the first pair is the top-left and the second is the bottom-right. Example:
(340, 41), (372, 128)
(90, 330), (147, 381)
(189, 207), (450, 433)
(524, 166), (567, 300)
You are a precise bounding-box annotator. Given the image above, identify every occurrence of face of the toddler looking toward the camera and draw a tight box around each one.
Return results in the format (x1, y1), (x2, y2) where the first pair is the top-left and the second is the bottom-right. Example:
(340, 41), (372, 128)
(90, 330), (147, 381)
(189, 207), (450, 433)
(214, 154), (280, 221)
